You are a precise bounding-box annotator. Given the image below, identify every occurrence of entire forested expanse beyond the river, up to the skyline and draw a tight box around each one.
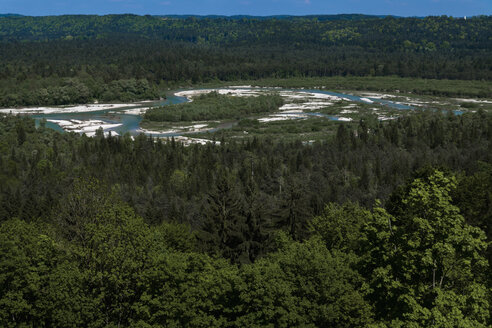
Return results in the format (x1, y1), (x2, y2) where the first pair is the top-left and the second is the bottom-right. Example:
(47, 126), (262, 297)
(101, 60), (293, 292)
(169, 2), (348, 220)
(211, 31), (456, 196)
(0, 15), (492, 106)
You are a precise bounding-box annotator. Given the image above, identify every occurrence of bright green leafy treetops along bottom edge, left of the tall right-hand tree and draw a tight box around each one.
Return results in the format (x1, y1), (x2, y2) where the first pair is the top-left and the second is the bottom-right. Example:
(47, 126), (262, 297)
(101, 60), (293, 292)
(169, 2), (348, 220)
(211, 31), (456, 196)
(0, 204), (371, 327)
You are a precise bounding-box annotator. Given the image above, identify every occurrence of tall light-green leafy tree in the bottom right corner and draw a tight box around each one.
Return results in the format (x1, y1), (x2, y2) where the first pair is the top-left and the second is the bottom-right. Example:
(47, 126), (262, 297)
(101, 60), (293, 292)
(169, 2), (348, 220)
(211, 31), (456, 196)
(361, 171), (490, 327)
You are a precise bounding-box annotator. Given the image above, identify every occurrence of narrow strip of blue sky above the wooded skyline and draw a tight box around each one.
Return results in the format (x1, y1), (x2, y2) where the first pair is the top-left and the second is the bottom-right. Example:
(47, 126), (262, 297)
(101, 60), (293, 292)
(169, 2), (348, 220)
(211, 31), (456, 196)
(0, 0), (492, 17)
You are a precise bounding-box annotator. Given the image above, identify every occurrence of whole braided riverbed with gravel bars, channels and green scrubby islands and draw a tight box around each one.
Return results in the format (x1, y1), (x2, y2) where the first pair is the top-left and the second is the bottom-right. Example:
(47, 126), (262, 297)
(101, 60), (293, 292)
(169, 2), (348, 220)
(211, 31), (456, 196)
(6, 85), (492, 140)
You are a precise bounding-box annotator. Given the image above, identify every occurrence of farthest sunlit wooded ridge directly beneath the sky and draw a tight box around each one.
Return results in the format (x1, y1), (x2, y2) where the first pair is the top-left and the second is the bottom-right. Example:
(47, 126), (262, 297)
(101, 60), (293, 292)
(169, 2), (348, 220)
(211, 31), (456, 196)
(0, 15), (491, 51)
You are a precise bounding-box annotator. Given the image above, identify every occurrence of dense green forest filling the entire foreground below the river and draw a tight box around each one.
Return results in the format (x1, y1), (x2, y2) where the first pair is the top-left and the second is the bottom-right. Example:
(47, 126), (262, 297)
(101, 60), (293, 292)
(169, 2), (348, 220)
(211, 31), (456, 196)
(0, 111), (492, 327)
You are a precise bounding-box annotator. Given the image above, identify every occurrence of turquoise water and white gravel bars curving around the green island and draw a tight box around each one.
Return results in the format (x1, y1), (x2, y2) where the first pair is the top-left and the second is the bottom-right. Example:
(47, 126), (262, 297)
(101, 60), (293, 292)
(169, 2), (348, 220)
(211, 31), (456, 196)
(6, 87), (413, 137)
